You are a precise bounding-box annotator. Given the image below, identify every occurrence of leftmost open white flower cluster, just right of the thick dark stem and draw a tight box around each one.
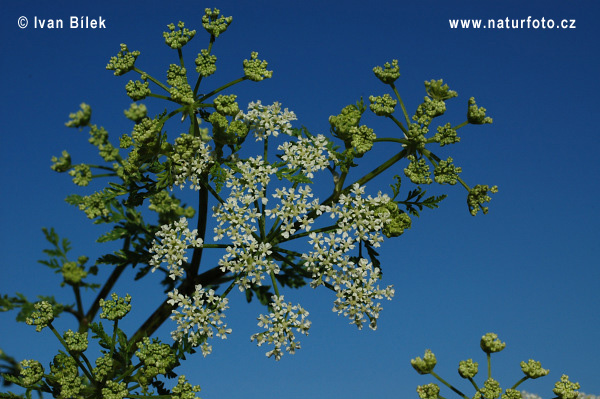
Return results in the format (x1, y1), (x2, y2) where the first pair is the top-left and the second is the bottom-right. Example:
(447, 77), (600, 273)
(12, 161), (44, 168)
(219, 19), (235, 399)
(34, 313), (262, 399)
(149, 217), (202, 280)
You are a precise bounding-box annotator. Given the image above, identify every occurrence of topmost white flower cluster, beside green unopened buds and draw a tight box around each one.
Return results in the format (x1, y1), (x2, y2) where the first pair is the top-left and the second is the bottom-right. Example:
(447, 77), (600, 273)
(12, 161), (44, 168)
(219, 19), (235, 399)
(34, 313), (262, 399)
(236, 100), (298, 141)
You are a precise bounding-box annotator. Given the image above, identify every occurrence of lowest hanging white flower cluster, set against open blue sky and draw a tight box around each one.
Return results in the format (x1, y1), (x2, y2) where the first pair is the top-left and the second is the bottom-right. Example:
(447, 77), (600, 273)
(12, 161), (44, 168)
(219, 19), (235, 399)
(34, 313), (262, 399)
(251, 295), (310, 360)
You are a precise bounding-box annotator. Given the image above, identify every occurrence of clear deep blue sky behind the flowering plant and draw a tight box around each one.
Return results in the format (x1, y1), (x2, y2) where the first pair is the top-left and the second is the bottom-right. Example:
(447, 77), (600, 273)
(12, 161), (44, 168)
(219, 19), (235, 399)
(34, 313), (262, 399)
(0, 0), (600, 399)
